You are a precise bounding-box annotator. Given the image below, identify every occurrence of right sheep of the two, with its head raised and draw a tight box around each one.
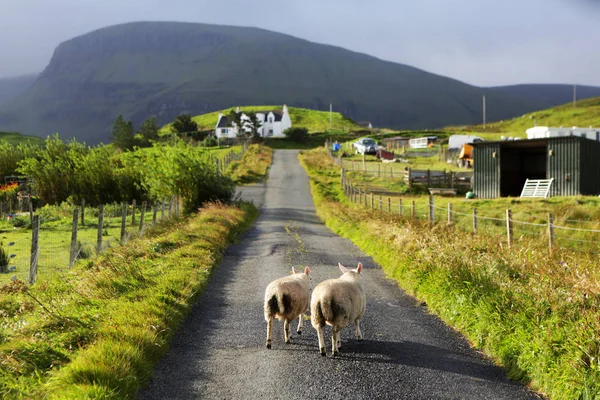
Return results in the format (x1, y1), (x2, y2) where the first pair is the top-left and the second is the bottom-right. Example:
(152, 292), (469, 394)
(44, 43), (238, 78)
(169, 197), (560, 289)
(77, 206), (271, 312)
(310, 263), (367, 356)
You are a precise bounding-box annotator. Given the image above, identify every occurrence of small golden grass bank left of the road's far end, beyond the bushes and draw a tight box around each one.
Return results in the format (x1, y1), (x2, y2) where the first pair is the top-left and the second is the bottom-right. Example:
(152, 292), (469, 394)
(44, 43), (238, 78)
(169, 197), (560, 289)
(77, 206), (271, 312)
(227, 144), (273, 184)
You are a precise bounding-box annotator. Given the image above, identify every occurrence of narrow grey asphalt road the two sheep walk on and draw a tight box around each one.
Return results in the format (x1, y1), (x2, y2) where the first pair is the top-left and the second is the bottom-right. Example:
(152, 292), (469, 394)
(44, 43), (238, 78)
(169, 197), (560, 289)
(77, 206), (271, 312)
(139, 150), (537, 400)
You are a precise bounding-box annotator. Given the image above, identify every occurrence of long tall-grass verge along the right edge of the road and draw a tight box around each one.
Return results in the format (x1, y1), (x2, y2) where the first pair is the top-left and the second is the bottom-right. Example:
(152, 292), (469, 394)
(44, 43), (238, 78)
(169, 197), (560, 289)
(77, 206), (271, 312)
(300, 149), (600, 399)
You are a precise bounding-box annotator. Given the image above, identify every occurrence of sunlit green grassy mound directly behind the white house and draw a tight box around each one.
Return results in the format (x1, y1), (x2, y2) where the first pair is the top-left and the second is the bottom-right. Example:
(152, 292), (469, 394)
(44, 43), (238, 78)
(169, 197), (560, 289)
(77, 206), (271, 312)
(161, 106), (361, 132)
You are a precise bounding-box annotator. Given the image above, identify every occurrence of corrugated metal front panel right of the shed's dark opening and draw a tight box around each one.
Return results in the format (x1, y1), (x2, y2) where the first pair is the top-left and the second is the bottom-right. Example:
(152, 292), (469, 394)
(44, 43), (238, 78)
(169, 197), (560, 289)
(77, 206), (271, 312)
(548, 137), (580, 196)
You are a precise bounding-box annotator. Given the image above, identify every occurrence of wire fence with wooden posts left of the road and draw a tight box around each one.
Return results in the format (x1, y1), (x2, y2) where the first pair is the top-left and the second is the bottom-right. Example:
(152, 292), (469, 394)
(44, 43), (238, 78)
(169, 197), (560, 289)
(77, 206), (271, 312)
(0, 144), (247, 284)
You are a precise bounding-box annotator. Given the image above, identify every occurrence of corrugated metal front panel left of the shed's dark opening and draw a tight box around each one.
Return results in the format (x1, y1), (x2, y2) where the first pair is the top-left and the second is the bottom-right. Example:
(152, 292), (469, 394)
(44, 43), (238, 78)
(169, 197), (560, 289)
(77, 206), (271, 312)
(473, 143), (501, 199)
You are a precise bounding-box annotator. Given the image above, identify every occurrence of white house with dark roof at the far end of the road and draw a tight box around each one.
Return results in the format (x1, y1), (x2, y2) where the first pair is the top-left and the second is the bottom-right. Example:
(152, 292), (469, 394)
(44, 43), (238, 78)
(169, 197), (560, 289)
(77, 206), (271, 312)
(215, 104), (292, 138)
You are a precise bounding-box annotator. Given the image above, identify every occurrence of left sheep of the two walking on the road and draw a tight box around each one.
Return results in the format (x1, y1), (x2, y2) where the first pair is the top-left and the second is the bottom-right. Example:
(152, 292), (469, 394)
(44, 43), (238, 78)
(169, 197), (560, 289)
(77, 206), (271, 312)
(265, 267), (310, 349)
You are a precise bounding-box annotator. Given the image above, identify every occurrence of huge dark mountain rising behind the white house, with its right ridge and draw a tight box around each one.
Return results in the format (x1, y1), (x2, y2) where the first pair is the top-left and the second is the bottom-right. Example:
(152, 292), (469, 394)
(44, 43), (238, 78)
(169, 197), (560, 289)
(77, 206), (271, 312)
(0, 22), (600, 144)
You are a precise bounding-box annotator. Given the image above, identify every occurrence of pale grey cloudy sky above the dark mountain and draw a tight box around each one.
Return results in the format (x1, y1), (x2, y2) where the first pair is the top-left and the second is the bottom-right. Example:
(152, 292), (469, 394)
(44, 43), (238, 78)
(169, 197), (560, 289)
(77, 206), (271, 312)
(0, 0), (600, 86)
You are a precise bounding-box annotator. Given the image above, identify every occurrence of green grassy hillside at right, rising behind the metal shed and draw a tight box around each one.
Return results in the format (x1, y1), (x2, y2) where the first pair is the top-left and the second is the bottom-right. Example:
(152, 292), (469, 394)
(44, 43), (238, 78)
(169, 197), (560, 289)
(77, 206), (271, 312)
(446, 97), (600, 137)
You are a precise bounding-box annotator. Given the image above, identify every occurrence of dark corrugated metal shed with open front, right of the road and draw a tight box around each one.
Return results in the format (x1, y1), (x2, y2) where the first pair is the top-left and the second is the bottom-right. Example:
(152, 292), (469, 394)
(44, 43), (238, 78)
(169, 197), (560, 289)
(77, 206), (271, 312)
(473, 136), (600, 198)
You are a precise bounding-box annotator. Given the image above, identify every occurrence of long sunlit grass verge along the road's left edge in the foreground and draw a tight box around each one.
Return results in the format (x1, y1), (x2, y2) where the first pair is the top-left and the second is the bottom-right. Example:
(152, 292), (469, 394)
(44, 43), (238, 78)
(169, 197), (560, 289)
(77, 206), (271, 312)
(0, 204), (257, 399)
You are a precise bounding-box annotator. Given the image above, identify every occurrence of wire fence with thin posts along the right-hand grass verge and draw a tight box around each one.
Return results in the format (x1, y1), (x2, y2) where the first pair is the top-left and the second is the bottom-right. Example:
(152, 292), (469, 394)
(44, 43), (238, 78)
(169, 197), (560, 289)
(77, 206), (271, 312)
(341, 170), (600, 254)
